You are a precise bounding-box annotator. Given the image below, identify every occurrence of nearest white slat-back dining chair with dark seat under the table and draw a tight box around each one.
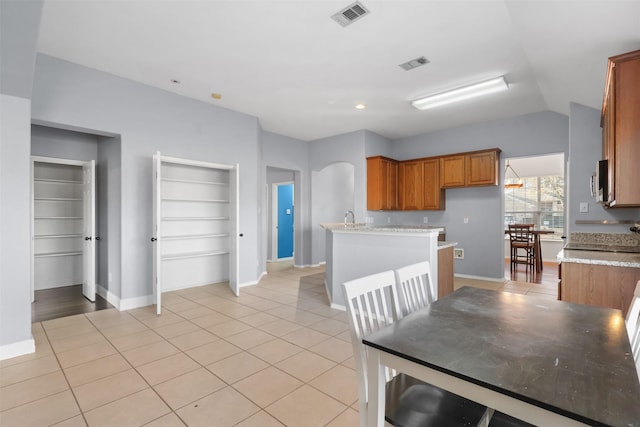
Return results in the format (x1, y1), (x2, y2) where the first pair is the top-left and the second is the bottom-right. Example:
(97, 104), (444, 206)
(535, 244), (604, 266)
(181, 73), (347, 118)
(342, 271), (493, 427)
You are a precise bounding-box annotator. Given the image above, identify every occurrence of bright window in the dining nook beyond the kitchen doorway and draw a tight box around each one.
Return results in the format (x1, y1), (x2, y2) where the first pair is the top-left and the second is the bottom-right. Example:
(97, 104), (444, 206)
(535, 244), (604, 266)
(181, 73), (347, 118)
(504, 175), (564, 239)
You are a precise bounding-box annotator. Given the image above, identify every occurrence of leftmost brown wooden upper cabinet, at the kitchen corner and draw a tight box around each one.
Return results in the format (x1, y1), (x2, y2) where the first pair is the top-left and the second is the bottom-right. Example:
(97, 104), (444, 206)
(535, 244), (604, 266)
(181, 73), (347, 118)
(367, 156), (398, 211)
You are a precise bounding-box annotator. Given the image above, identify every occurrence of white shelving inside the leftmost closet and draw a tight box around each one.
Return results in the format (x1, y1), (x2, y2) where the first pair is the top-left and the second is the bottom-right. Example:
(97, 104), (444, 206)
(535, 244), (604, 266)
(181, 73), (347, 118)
(33, 161), (83, 289)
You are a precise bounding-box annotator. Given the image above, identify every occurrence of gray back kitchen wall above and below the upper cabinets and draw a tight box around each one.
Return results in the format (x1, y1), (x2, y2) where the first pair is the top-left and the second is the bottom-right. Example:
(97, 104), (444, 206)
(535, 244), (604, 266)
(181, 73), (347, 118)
(368, 112), (569, 279)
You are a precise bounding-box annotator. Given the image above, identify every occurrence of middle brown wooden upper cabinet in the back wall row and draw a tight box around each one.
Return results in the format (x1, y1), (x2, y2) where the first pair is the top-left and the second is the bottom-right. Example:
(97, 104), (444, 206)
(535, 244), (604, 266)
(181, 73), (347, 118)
(398, 158), (444, 210)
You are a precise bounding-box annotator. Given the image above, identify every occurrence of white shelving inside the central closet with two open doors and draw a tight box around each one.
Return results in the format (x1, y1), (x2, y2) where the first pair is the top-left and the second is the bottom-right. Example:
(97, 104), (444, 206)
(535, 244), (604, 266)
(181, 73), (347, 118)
(159, 162), (230, 290)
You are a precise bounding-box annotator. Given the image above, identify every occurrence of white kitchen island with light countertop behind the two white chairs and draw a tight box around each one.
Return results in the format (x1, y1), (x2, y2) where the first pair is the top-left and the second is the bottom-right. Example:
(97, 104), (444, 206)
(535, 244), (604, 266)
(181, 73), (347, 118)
(321, 223), (444, 309)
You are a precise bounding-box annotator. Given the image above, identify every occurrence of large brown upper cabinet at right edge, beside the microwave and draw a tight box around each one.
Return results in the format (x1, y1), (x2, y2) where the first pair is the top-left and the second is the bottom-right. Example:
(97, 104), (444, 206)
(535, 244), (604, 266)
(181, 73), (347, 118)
(600, 50), (640, 207)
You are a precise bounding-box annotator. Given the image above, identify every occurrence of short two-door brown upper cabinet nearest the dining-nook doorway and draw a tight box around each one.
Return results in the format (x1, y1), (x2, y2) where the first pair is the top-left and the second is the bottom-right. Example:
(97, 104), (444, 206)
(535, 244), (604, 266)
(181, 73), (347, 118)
(440, 148), (501, 188)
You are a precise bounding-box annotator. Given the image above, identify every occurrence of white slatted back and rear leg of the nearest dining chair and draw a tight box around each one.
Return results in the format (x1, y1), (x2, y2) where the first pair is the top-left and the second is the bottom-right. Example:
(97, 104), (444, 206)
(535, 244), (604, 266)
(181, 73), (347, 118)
(342, 271), (400, 426)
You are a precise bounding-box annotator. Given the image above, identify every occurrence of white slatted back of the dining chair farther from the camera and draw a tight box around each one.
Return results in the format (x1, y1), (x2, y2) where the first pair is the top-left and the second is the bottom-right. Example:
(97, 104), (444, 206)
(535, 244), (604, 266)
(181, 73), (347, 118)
(395, 261), (437, 316)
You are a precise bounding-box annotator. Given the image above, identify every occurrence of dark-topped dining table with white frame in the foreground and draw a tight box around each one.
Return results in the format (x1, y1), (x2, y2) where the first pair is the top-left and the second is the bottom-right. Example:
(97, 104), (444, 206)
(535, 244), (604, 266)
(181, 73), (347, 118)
(363, 287), (640, 427)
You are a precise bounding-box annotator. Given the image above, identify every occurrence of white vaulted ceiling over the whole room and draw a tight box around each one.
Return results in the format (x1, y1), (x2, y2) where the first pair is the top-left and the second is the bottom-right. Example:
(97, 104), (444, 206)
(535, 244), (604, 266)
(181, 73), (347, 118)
(38, 0), (640, 140)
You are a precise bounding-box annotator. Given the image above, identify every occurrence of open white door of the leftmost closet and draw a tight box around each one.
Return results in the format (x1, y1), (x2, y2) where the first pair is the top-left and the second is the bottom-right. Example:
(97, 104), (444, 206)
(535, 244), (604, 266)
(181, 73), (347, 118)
(82, 160), (96, 302)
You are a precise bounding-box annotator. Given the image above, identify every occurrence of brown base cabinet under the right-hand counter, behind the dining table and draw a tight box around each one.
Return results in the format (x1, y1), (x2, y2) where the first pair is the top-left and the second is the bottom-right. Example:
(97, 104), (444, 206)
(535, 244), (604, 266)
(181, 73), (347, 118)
(558, 262), (640, 316)
